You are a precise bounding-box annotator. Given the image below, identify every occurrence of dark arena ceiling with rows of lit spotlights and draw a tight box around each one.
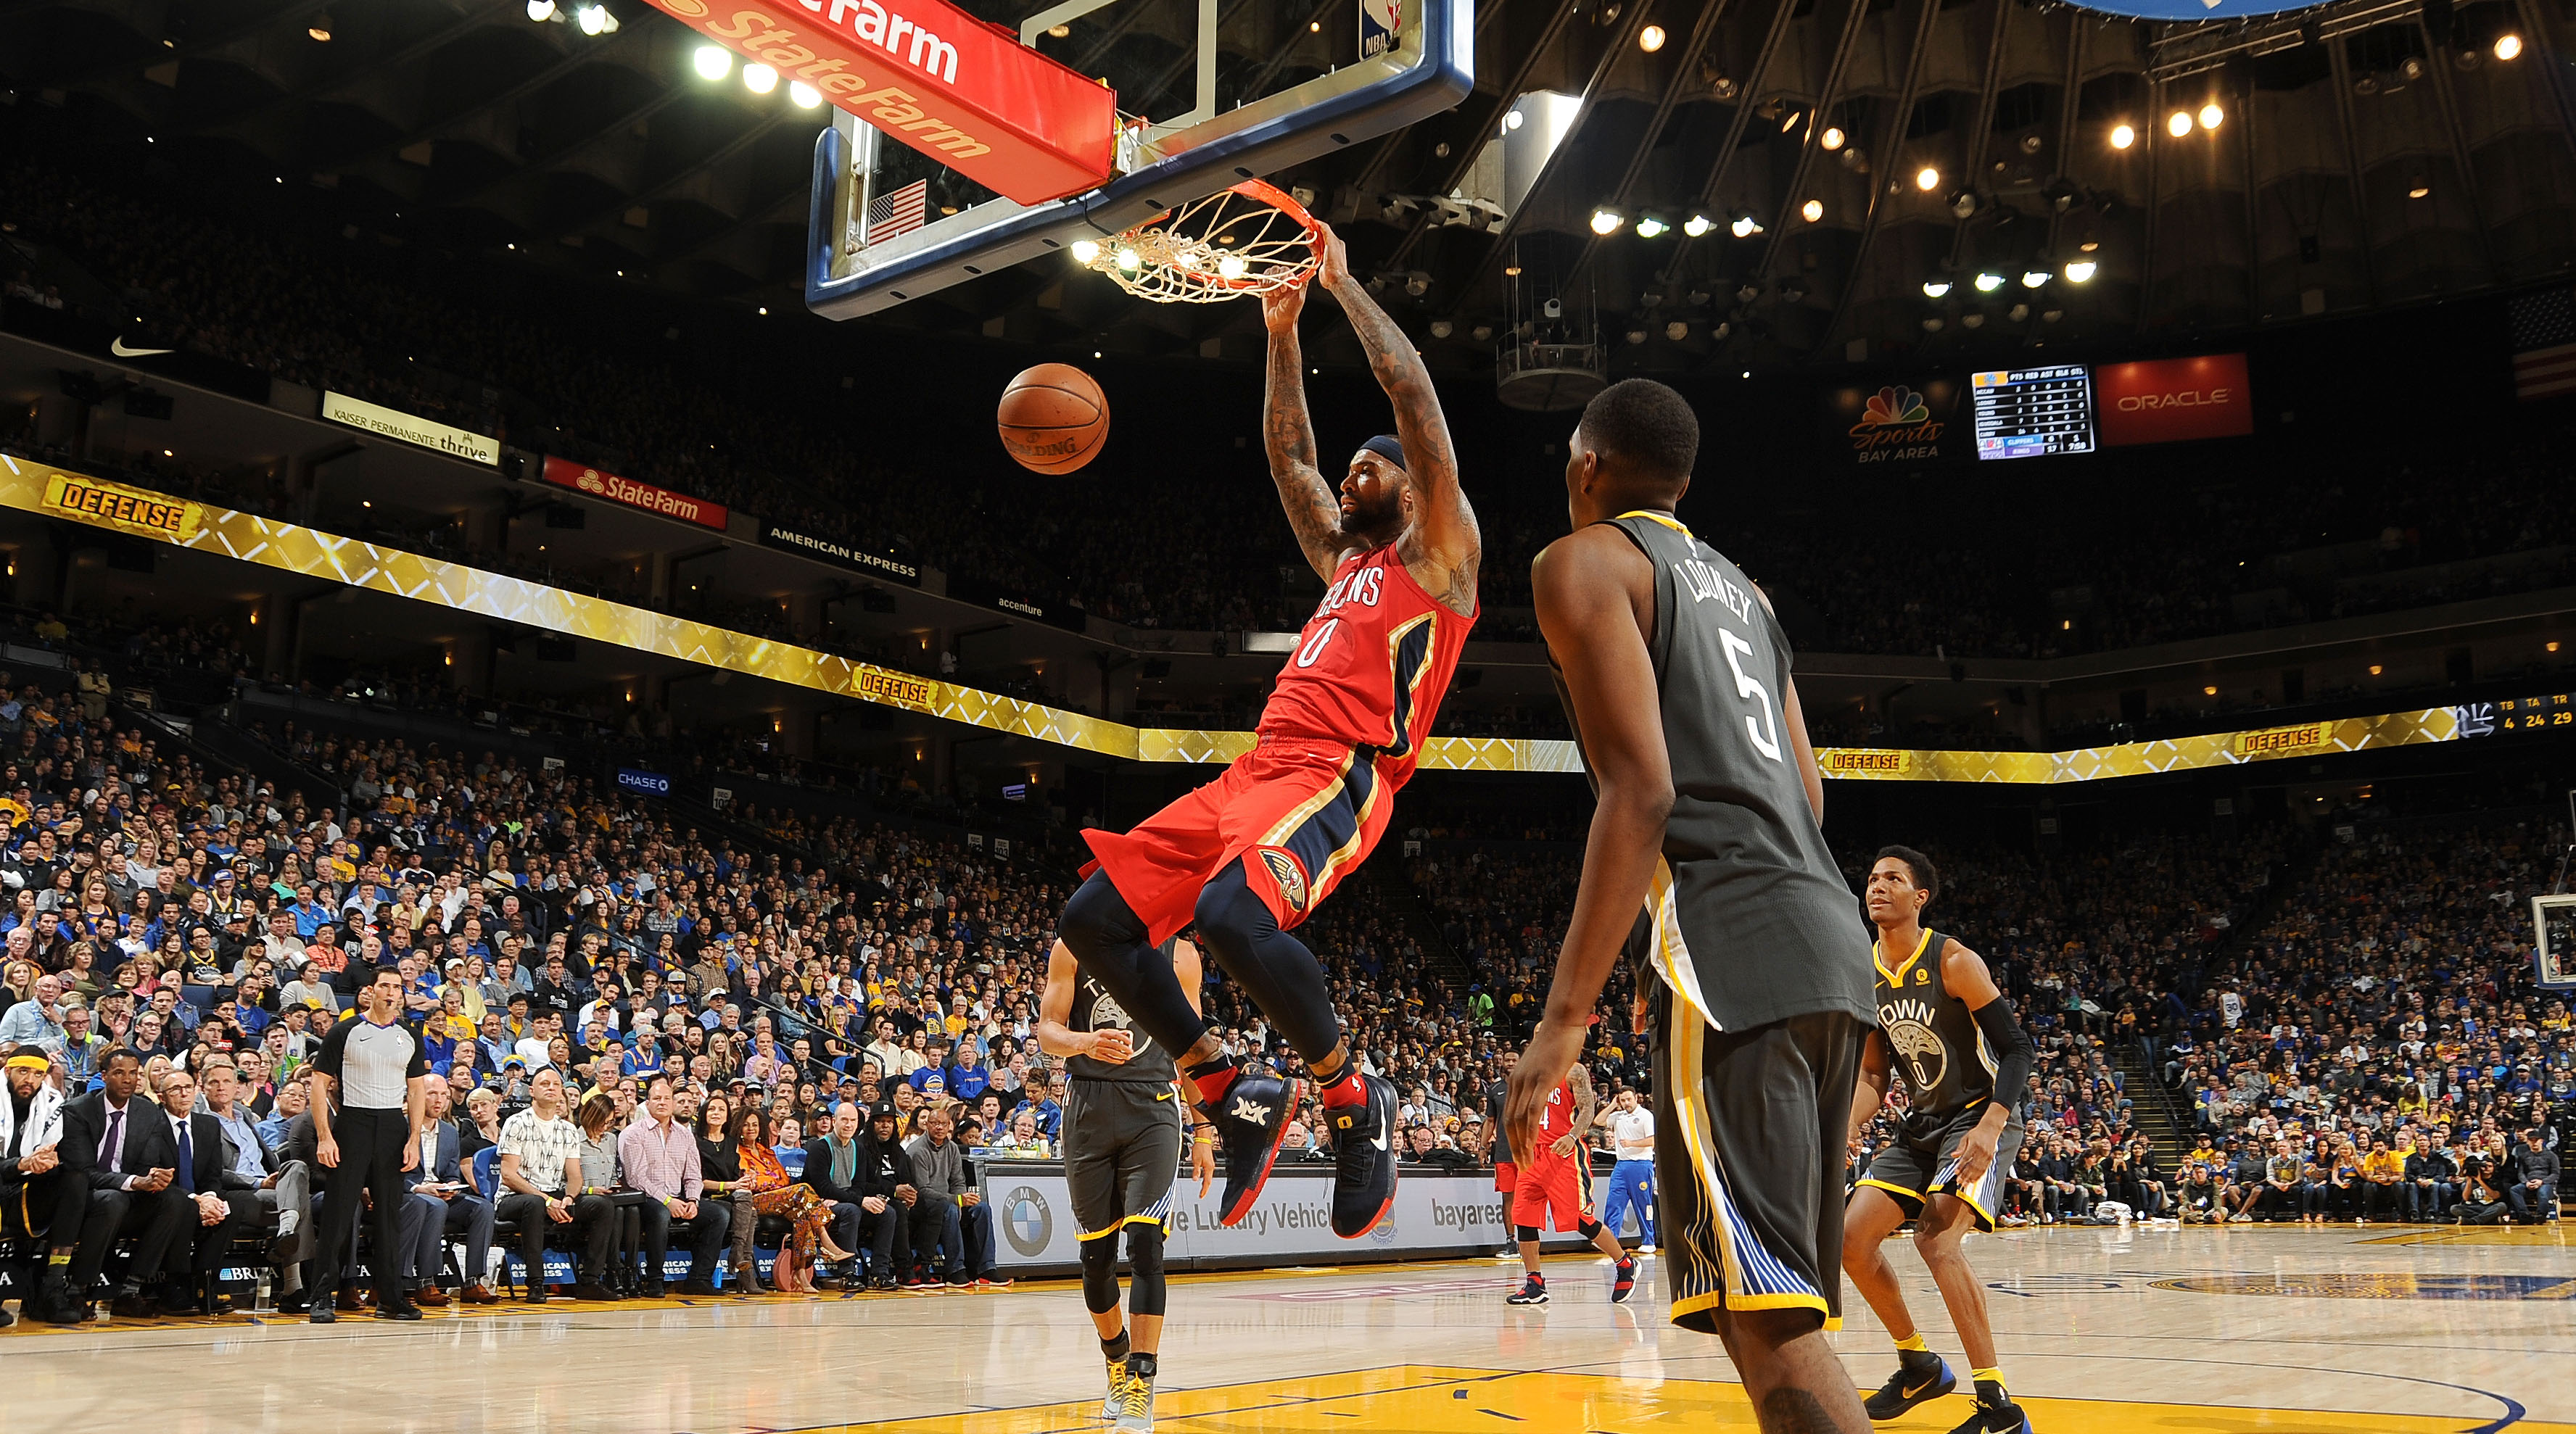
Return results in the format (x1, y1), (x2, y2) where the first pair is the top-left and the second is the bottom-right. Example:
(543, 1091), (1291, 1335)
(0, 0), (2576, 368)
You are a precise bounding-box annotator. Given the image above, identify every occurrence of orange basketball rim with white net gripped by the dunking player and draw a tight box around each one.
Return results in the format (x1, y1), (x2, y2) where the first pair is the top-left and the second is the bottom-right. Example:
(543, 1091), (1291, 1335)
(1074, 181), (1324, 304)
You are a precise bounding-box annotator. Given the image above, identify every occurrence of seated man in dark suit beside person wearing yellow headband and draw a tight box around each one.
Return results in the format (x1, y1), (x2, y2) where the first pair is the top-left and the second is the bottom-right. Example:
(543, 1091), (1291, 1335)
(51, 1045), (193, 1316)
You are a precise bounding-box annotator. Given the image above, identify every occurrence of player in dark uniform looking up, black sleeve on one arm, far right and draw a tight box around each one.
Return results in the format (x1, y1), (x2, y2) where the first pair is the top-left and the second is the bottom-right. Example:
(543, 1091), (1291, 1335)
(1842, 847), (2035, 1434)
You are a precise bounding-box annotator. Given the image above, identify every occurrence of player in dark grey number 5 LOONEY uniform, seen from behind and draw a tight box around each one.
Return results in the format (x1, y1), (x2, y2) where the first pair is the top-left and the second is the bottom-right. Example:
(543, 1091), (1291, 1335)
(1509, 378), (1875, 1434)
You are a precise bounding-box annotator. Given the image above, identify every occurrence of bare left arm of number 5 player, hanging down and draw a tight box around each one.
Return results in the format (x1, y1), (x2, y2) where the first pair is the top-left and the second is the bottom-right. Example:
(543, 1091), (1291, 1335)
(1504, 525), (1672, 1151)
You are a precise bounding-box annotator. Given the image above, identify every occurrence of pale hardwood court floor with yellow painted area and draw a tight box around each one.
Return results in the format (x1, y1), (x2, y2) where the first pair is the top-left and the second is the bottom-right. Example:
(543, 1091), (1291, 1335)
(15, 1225), (2576, 1434)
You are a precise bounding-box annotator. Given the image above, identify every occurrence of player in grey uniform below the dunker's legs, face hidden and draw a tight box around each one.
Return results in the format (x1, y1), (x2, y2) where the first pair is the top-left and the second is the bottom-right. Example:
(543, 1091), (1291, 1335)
(1038, 937), (1216, 1434)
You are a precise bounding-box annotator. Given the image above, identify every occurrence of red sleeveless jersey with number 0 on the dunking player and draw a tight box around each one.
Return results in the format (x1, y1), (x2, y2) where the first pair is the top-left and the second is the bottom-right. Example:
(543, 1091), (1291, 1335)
(1260, 543), (1481, 783)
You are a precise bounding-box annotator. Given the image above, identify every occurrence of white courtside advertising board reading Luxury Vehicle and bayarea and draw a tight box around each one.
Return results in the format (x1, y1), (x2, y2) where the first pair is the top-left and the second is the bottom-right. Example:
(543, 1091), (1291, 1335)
(984, 1161), (1636, 1275)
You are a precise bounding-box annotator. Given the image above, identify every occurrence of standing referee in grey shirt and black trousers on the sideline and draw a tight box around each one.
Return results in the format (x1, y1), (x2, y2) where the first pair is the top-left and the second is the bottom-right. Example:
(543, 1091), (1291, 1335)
(312, 966), (430, 1323)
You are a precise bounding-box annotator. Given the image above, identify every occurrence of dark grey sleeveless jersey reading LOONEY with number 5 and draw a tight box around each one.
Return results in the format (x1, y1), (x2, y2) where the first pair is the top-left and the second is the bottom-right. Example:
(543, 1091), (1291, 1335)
(1551, 513), (1878, 1029)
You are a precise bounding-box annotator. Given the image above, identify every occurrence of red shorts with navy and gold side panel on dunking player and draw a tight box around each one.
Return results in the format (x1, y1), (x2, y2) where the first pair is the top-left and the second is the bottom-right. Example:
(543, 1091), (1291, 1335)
(1082, 737), (1396, 942)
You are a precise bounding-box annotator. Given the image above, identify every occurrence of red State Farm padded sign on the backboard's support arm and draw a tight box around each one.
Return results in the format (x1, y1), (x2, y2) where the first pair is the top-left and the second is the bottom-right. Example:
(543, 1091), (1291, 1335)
(652, 0), (1118, 204)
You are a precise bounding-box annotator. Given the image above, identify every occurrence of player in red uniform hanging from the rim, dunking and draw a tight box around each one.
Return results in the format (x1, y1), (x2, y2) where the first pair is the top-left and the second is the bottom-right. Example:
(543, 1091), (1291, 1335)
(1059, 227), (1494, 1238)
